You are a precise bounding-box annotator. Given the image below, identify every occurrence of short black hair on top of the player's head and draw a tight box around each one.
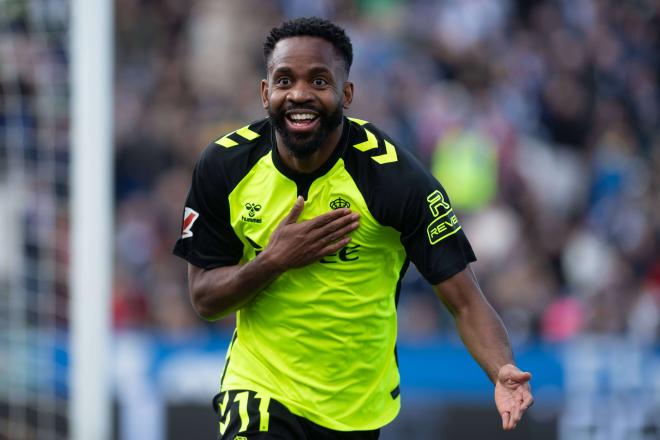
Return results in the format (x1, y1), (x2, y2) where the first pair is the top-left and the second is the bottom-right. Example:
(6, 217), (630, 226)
(264, 17), (353, 74)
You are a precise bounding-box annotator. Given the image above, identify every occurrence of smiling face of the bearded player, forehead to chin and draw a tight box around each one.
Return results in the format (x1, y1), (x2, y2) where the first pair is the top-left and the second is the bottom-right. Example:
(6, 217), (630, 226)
(261, 37), (353, 159)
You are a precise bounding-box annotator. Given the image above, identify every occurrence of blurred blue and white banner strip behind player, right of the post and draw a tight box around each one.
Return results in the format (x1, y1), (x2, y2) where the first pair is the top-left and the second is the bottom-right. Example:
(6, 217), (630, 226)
(115, 333), (660, 440)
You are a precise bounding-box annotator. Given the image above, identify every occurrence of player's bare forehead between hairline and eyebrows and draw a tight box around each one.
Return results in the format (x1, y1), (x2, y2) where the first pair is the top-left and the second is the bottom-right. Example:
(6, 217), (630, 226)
(268, 37), (341, 71)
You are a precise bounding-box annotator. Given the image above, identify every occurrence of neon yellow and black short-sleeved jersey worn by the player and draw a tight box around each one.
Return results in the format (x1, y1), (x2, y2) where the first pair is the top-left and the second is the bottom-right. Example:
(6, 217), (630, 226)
(174, 118), (475, 431)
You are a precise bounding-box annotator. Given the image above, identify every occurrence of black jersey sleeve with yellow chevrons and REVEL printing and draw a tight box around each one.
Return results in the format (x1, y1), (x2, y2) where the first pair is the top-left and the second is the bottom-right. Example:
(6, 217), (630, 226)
(344, 122), (476, 284)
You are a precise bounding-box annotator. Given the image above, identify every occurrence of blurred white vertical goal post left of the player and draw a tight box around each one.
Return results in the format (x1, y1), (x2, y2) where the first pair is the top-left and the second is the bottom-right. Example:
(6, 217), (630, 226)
(69, 0), (114, 440)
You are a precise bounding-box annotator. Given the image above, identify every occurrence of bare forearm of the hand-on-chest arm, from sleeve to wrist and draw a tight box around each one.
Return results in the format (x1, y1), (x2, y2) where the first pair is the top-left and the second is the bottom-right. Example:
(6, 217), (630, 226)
(188, 253), (283, 321)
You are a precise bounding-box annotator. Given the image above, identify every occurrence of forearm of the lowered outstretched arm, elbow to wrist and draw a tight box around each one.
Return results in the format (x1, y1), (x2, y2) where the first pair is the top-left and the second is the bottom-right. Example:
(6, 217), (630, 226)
(454, 299), (513, 383)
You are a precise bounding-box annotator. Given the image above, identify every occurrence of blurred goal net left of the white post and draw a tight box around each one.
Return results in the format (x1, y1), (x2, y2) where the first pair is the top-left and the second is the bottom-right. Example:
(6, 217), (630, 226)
(0, 0), (70, 439)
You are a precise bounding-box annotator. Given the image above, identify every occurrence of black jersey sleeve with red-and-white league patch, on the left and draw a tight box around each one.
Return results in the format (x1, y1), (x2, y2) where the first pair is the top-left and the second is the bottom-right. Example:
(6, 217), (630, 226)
(173, 145), (243, 269)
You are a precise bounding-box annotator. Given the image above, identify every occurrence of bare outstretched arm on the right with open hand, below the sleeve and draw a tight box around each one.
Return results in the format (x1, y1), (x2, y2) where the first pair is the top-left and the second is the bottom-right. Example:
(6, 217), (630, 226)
(434, 266), (533, 430)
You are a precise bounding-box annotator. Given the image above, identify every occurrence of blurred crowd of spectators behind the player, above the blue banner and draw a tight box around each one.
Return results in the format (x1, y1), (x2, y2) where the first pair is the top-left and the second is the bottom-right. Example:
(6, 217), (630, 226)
(113, 0), (660, 344)
